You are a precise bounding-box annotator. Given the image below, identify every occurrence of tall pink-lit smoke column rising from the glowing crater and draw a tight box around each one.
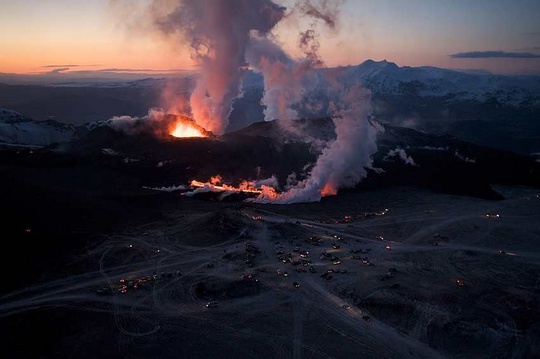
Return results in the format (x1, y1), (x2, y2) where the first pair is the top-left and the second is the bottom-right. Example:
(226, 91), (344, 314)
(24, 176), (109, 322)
(152, 0), (285, 134)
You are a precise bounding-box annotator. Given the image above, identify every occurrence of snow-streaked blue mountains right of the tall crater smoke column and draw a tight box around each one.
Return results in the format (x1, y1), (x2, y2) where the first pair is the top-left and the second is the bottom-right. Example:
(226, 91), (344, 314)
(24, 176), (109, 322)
(233, 60), (540, 154)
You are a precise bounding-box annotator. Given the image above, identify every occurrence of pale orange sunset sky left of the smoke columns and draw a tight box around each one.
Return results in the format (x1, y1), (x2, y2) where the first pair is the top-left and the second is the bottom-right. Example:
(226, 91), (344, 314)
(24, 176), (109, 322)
(0, 0), (194, 75)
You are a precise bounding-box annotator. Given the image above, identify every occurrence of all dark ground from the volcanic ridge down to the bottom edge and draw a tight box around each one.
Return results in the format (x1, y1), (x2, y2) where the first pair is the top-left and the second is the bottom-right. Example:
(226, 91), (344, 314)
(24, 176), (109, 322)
(0, 120), (540, 359)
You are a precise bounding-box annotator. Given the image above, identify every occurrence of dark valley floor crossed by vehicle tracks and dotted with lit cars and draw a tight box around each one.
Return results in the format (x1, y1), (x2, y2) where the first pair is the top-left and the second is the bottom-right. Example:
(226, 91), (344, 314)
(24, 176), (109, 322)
(0, 187), (540, 359)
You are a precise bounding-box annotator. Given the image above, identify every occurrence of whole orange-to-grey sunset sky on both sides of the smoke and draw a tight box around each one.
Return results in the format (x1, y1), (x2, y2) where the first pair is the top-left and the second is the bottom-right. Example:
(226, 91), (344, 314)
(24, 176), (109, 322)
(0, 0), (540, 74)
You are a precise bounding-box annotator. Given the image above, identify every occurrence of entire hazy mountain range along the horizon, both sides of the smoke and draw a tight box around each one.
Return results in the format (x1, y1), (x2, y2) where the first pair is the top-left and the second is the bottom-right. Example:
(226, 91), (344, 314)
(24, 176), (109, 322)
(0, 60), (540, 154)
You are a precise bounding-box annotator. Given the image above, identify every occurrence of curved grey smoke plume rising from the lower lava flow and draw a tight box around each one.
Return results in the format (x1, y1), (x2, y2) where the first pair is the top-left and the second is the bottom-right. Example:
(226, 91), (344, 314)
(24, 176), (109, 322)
(247, 0), (378, 203)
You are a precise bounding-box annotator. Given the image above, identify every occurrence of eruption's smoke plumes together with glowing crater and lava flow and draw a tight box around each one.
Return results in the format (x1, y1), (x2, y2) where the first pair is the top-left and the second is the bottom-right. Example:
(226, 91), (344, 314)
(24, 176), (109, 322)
(135, 0), (377, 204)
